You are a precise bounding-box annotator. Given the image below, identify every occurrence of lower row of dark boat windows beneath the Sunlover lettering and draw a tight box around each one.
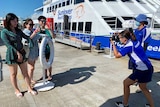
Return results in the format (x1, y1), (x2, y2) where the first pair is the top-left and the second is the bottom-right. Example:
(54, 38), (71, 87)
(55, 22), (92, 32)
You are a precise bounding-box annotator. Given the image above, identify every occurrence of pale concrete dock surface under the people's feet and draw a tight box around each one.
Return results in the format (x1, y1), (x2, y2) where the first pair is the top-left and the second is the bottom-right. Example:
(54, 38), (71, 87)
(0, 42), (160, 107)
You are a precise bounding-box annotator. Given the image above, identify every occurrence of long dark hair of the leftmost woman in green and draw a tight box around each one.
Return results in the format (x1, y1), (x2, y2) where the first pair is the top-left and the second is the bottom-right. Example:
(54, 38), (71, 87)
(5, 13), (18, 30)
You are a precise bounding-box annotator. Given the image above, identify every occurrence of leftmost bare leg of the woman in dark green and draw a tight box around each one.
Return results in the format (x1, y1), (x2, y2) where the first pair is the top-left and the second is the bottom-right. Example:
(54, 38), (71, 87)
(9, 64), (20, 93)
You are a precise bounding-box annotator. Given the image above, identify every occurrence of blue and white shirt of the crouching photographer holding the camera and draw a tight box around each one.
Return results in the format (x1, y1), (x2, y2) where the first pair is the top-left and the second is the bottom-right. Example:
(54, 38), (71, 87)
(119, 40), (152, 71)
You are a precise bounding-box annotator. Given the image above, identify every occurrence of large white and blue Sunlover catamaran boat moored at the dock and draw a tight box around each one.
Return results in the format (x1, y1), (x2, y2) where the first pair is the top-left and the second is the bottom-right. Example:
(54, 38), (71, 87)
(32, 0), (160, 59)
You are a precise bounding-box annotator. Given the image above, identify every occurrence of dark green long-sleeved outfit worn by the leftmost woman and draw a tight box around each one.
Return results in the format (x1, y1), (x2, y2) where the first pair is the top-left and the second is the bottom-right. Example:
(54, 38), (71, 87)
(1, 29), (33, 64)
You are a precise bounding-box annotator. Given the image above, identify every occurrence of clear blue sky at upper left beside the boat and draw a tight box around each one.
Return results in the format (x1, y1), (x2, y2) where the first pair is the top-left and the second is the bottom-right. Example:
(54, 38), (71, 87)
(0, 0), (43, 18)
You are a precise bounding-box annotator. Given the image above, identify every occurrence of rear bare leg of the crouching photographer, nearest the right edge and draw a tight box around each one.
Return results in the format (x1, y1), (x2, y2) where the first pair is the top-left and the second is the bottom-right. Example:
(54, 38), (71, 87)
(139, 83), (154, 107)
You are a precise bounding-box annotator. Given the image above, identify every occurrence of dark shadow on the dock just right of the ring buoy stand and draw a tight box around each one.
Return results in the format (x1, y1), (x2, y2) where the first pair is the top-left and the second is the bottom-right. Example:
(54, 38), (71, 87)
(52, 66), (96, 87)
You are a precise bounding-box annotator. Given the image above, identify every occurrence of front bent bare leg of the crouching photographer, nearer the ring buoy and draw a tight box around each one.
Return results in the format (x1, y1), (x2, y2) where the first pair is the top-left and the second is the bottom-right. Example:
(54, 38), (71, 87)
(123, 78), (135, 105)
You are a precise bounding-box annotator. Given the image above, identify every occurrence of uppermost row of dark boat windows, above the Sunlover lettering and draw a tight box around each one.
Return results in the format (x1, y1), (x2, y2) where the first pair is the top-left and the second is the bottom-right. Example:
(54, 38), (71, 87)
(47, 0), (135, 13)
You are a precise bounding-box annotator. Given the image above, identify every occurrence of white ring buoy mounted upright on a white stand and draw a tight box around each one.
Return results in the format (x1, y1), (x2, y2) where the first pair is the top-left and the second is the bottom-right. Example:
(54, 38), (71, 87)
(39, 36), (54, 69)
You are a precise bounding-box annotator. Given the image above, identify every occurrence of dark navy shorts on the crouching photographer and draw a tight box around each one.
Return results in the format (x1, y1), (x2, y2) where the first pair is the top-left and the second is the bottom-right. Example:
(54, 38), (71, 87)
(128, 67), (154, 83)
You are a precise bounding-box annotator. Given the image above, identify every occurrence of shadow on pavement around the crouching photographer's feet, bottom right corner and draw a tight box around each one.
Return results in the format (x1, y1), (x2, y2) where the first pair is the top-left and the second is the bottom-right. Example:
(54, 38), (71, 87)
(99, 72), (160, 107)
